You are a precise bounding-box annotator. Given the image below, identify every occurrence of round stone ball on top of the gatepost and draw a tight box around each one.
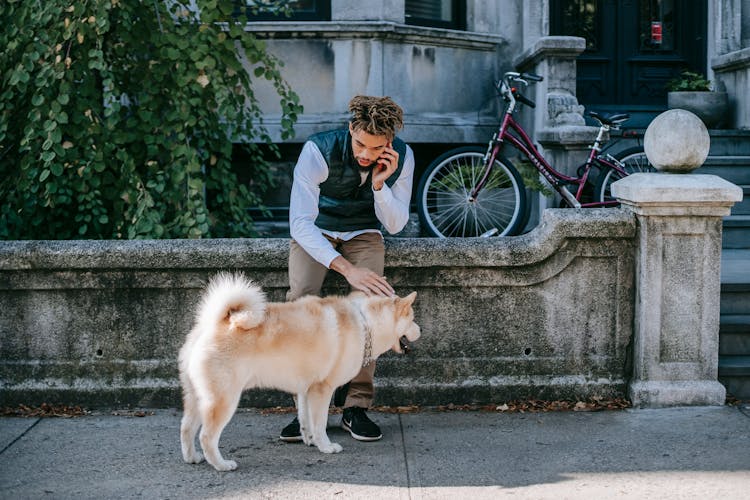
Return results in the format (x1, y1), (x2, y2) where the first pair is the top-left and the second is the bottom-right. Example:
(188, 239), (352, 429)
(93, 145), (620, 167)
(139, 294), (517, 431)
(643, 109), (711, 173)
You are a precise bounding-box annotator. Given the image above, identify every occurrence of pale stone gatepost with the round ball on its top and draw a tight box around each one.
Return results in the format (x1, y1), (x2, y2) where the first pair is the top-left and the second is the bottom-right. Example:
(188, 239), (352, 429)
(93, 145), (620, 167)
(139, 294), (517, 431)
(612, 110), (742, 407)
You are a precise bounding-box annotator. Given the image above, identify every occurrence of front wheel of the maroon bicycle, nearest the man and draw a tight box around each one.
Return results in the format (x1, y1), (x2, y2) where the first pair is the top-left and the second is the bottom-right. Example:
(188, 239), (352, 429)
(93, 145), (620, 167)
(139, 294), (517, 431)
(417, 147), (526, 238)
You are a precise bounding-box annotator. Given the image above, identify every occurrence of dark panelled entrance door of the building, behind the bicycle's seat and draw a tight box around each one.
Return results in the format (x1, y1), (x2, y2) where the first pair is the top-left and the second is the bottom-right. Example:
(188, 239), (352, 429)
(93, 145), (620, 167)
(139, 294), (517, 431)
(550, 0), (708, 127)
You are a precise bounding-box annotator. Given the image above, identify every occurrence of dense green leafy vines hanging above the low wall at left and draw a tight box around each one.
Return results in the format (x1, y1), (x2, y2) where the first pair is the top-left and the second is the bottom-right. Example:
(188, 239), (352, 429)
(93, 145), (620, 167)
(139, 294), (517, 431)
(0, 0), (302, 239)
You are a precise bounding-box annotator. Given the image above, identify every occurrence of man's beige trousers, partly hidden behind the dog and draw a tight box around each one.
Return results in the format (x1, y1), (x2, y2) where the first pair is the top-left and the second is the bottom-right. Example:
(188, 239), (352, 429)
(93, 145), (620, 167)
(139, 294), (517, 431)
(286, 233), (385, 408)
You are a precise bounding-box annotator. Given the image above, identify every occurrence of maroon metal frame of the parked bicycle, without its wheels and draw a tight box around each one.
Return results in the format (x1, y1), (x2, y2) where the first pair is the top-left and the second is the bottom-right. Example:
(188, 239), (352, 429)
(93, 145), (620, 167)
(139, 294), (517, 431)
(476, 92), (627, 208)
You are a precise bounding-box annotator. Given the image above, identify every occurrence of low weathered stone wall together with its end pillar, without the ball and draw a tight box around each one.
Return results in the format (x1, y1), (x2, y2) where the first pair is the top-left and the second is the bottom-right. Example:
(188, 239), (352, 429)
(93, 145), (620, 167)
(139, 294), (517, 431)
(0, 165), (742, 407)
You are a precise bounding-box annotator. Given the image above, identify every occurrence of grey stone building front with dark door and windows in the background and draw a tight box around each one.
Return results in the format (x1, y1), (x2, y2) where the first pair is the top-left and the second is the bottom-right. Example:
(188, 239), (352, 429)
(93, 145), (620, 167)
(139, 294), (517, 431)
(244, 0), (750, 225)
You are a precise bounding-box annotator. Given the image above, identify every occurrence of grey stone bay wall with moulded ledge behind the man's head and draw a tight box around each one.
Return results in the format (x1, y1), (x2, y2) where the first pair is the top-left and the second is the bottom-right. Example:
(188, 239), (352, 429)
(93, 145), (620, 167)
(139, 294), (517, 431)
(246, 20), (510, 143)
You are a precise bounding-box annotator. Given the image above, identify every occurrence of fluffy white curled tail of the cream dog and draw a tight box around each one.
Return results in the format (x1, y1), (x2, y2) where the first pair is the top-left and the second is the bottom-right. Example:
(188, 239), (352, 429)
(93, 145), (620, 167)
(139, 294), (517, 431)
(198, 272), (266, 331)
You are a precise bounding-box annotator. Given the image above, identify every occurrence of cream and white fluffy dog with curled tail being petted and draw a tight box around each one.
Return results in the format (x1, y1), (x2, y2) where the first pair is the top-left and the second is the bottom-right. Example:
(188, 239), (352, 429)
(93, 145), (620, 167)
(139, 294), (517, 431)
(179, 273), (420, 471)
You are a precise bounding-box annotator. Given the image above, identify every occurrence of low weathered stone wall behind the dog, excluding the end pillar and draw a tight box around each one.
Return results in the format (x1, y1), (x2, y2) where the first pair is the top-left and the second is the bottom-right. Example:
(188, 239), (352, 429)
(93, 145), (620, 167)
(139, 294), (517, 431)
(0, 209), (635, 406)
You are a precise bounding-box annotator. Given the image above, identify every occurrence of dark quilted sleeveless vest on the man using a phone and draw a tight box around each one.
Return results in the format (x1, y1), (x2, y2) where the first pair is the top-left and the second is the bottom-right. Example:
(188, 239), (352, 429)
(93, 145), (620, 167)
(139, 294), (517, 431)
(309, 129), (406, 231)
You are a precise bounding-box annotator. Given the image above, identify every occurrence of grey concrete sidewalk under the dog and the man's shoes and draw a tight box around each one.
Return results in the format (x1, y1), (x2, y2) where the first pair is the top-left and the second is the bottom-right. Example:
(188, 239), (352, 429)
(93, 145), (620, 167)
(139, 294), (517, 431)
(0, 405), (750, 500)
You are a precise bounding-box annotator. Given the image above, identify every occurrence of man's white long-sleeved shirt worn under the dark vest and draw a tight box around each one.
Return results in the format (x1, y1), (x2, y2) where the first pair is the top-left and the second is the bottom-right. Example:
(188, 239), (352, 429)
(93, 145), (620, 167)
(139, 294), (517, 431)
(289, 141), (414, 268)
